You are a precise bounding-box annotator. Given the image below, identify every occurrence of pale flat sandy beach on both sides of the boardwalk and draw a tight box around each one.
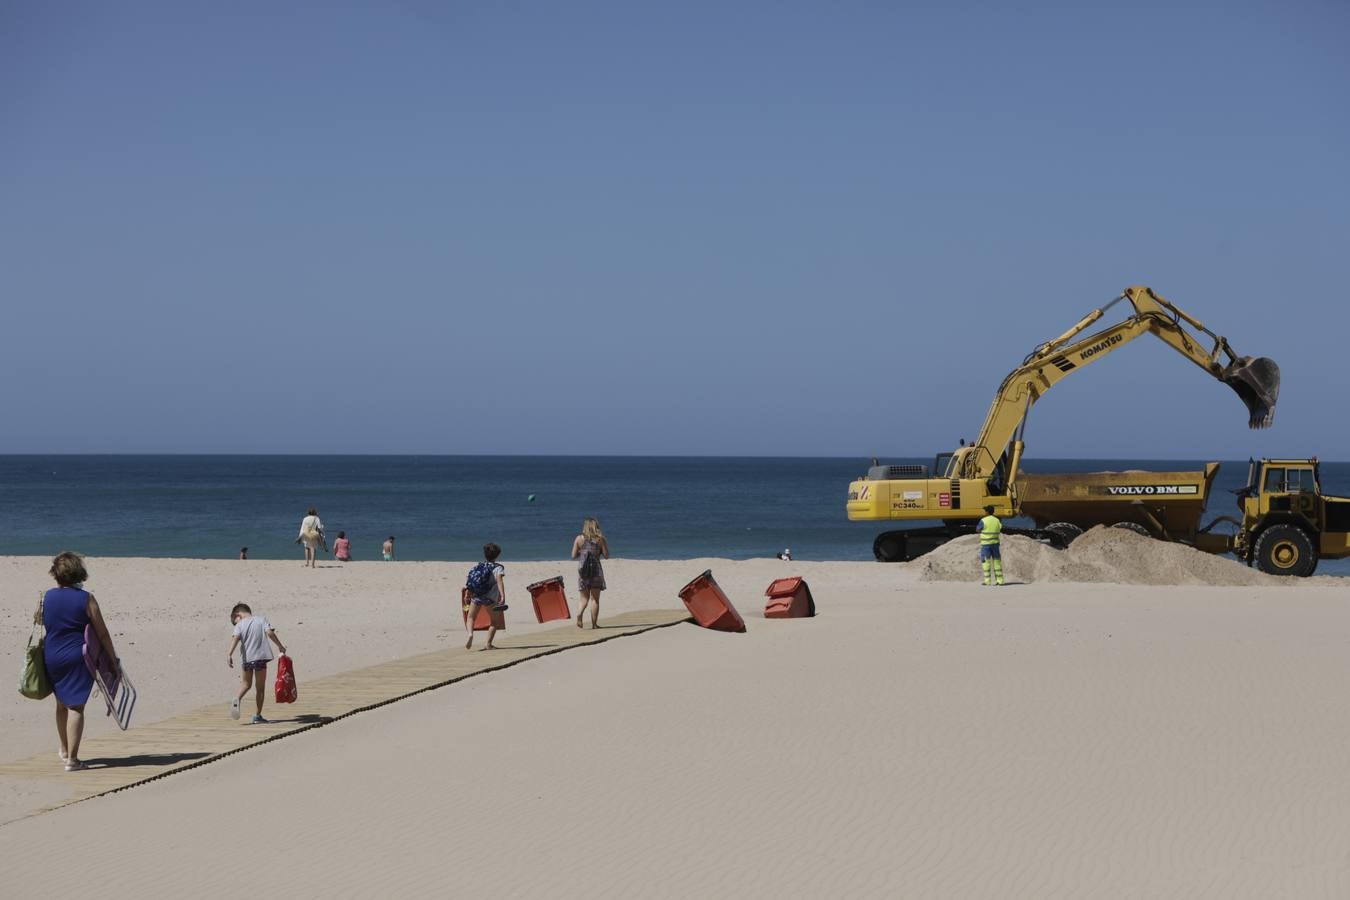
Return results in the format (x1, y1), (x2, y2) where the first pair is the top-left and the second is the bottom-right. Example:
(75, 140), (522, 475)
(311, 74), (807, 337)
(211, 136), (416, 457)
(0, 557), (1350, 897)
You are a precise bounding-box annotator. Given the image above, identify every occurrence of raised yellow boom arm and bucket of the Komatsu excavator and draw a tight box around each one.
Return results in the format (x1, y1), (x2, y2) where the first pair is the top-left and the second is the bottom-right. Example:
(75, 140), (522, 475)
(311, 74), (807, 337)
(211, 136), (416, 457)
(949, 286), (1280, 478)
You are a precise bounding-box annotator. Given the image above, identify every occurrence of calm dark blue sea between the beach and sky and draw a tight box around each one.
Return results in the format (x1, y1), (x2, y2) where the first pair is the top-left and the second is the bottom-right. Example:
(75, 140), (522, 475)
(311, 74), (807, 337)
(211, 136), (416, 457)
(0, 456), (1350, 573)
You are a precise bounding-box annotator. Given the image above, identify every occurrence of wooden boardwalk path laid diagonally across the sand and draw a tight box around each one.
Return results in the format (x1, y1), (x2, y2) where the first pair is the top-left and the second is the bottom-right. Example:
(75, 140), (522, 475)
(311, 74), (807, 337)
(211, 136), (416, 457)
(0, 609), (689, 811)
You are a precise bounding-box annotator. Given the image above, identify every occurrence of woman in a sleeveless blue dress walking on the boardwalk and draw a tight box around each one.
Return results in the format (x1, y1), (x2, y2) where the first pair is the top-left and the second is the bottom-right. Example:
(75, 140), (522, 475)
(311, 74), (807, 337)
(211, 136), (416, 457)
(42, 551), (117, 772)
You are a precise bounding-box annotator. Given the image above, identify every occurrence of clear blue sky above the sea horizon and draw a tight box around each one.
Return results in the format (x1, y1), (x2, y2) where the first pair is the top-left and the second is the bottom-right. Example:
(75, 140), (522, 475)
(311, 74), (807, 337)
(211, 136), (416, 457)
(0, 0), (1350, 459)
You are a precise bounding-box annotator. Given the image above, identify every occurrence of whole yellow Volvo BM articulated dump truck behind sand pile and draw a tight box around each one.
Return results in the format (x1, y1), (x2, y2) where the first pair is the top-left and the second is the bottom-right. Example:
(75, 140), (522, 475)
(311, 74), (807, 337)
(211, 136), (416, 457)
(1018, 457), (1350, 576)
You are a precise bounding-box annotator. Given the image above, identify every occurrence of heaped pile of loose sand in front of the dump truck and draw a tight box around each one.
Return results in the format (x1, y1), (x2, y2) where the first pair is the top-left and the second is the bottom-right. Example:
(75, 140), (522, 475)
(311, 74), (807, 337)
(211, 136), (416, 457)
(907, 526), (1299, 587)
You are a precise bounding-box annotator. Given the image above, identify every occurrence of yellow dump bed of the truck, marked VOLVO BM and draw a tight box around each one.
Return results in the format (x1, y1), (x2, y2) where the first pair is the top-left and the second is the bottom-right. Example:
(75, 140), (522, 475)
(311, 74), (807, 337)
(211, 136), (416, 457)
(1017, 463), (1219, 540)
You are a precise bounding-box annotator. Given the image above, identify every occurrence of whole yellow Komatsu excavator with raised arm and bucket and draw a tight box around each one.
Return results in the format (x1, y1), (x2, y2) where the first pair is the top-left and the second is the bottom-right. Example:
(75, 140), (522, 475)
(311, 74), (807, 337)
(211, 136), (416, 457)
(848, 286), (1280, 561)
